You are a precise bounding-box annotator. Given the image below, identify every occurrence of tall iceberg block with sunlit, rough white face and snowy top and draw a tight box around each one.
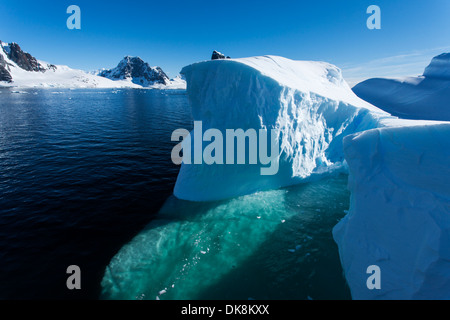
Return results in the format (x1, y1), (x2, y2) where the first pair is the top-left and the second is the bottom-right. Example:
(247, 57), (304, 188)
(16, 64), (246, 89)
(174, 56), (393, 201)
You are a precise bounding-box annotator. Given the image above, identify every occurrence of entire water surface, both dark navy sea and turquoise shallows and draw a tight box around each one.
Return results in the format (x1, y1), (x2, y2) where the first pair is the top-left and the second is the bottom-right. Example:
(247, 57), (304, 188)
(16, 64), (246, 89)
(0, 89), (350, 300)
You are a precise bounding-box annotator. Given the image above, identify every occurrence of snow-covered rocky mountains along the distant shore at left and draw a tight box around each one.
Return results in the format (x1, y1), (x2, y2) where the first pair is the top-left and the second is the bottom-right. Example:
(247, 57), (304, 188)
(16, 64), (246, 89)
(0, 41), (186, 89)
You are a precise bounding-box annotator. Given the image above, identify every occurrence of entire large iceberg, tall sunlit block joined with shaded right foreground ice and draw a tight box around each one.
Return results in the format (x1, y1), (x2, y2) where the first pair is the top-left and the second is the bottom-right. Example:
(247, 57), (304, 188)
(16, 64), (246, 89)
(174, 56), (450, 299)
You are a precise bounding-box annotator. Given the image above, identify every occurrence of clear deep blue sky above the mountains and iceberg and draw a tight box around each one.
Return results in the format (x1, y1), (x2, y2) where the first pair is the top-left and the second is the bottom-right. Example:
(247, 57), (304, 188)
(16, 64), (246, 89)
(0, 0), (450, 82)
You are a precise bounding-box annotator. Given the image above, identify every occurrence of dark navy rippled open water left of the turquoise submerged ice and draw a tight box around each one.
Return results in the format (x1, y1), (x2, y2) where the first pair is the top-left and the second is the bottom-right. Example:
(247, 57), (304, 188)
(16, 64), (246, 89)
(0, 89), (192, 299)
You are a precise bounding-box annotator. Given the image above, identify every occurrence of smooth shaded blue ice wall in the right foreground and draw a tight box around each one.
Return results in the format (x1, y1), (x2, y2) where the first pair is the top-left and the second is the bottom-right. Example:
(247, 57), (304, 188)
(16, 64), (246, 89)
(333, 121), (450, 299)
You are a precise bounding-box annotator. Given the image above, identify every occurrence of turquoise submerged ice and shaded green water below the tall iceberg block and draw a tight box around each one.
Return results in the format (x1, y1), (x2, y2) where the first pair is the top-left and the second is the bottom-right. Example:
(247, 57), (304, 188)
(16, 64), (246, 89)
(102, 175), (350, 299)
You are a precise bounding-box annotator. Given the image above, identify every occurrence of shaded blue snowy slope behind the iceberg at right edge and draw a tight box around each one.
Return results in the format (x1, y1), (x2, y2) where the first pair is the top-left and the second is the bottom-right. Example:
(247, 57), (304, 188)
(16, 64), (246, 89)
(353, 53), (450, 121)
